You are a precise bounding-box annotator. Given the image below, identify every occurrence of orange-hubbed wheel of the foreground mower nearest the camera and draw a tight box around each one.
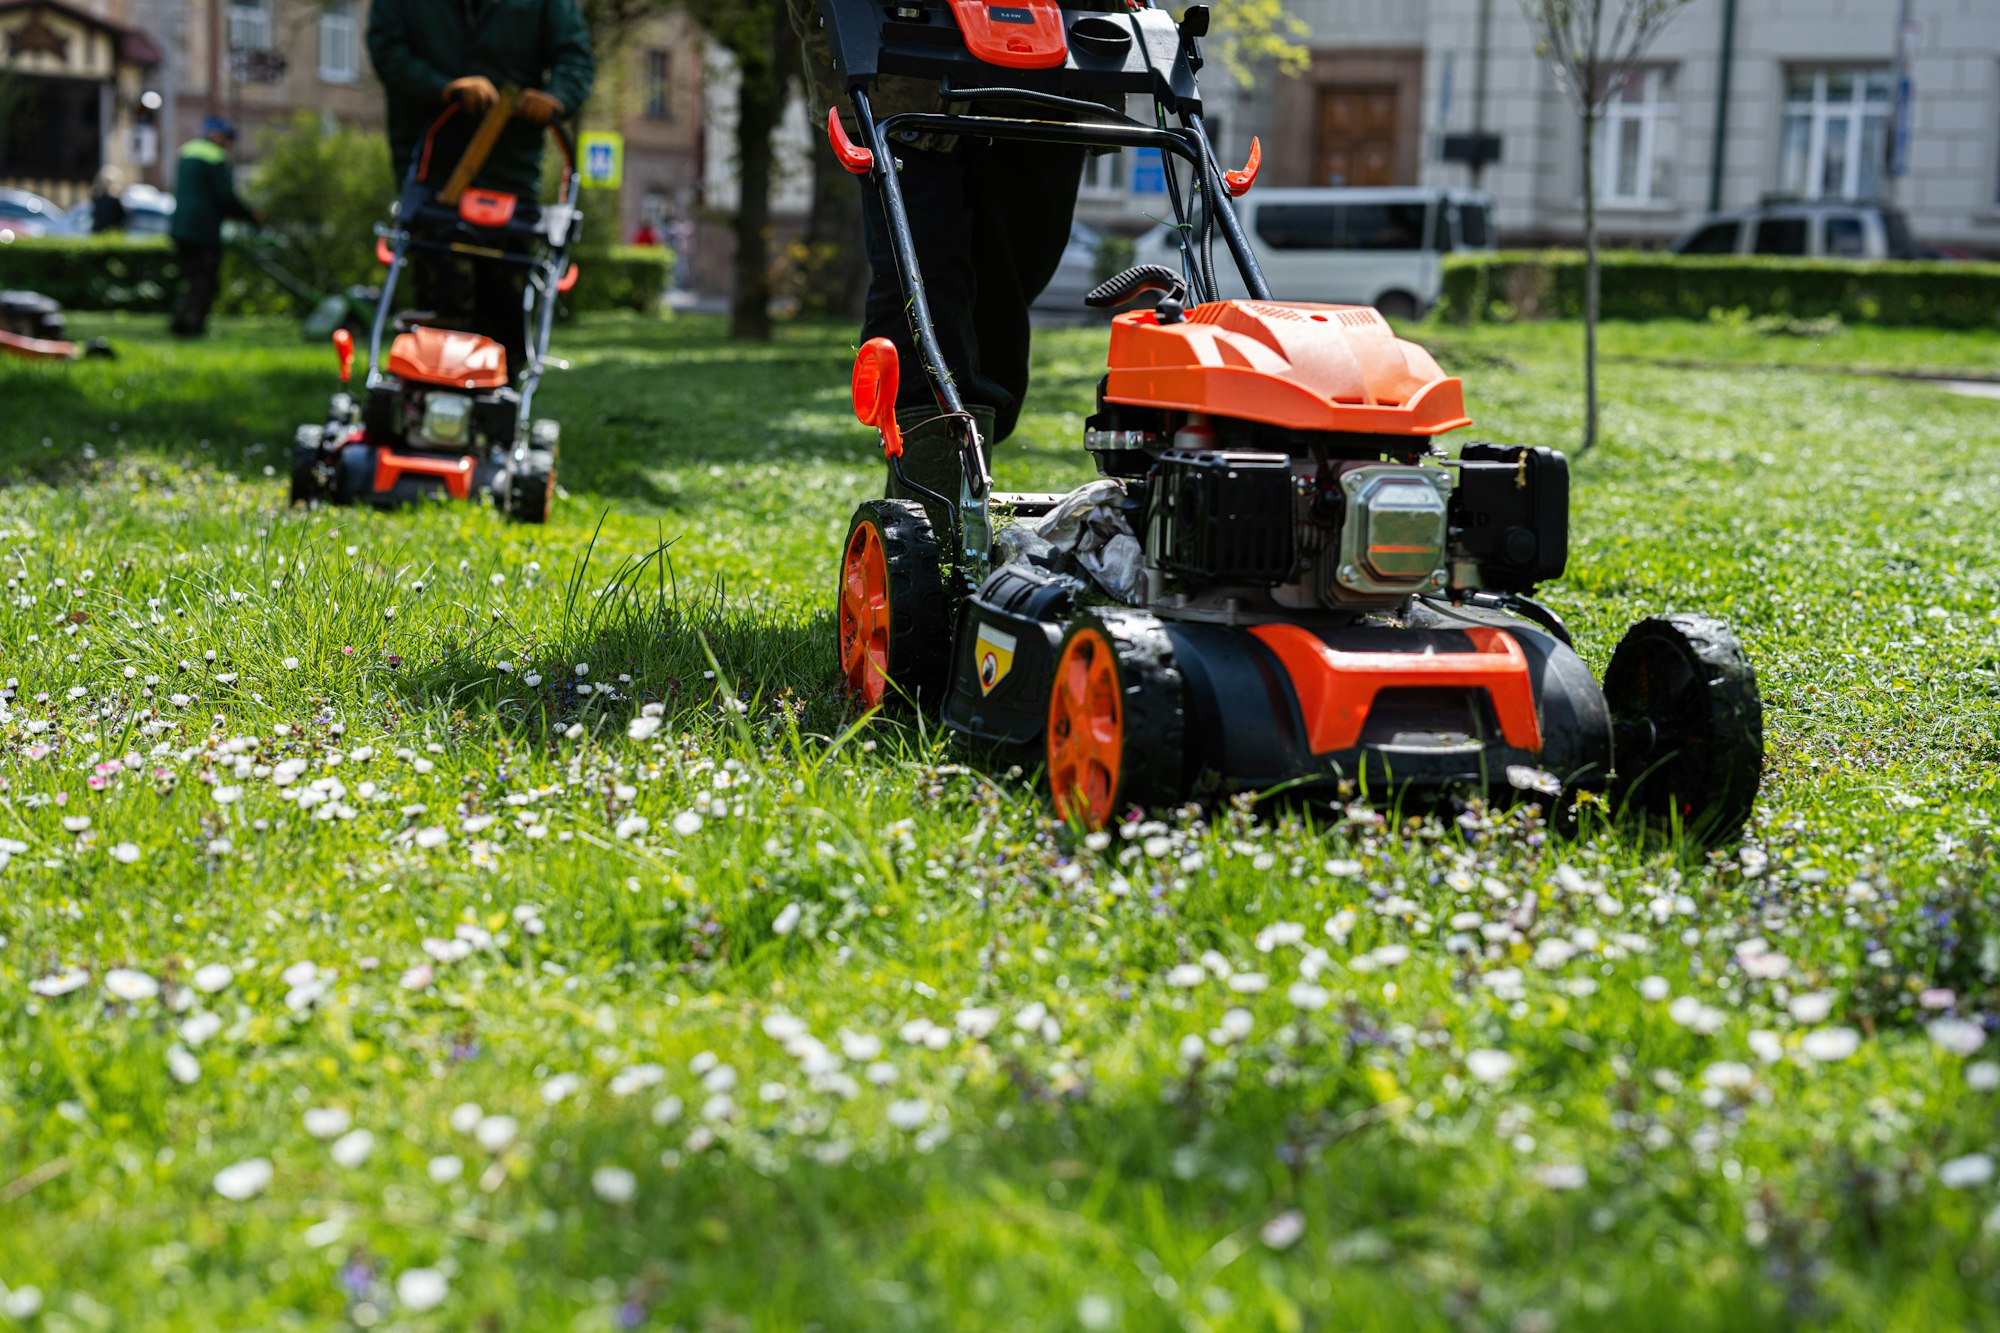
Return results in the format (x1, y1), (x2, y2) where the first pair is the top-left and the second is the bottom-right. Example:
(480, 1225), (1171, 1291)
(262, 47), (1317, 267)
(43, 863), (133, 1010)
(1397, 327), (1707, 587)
(1044, 610), (1186, 829)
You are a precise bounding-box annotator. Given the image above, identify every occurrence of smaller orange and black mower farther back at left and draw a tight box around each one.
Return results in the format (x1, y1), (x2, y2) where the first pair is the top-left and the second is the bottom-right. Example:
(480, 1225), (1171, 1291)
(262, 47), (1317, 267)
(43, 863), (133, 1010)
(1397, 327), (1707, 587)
(292, 98), (582, 522)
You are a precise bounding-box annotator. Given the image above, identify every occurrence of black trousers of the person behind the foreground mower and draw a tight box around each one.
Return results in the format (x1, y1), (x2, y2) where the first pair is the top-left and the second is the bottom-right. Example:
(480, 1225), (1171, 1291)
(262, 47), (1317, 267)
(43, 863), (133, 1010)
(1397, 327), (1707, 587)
(862, 138), (1084, 440)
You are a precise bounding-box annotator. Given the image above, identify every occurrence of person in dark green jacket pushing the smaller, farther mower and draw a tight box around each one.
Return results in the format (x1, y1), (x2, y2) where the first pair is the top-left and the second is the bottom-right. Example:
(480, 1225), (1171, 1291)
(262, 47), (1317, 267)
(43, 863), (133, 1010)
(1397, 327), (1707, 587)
(368, 0), (596, 374)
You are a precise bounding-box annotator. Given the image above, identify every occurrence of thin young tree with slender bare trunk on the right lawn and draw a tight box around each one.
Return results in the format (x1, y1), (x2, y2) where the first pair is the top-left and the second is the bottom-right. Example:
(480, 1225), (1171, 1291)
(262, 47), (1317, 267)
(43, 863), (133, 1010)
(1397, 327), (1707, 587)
(1520, 0), (1690, 454)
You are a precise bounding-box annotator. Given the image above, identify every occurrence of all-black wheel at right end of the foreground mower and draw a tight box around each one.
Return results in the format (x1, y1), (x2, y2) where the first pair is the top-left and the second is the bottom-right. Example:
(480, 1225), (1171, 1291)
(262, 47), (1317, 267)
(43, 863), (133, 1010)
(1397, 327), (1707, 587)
(1604, 614), (1764, 847)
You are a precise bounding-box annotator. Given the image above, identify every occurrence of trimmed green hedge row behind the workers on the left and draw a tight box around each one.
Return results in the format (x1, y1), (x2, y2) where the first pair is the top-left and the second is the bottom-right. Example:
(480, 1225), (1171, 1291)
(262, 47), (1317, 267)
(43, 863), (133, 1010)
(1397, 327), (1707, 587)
(0, 236), (674, 314)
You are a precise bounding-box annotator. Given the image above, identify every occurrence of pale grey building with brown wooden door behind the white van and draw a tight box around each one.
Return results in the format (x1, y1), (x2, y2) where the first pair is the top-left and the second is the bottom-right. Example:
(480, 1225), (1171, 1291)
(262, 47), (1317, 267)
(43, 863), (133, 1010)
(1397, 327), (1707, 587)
(1184, 0), (2000, 254)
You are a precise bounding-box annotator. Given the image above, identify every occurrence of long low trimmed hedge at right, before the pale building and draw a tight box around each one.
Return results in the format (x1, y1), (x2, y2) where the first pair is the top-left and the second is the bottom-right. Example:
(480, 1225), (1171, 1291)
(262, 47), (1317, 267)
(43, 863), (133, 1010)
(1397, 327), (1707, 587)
(1438, 250), (2000, 328)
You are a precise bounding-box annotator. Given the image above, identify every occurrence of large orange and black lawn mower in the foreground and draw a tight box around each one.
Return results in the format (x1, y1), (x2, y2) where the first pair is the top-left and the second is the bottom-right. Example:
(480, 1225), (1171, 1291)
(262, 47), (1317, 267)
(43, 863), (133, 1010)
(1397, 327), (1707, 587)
(820, 0), (1764, 841)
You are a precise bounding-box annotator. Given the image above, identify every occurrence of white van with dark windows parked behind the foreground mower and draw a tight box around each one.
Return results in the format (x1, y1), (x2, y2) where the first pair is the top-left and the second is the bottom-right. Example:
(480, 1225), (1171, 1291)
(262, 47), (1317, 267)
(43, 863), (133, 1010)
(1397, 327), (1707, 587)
(1138, 186), (1494, 318)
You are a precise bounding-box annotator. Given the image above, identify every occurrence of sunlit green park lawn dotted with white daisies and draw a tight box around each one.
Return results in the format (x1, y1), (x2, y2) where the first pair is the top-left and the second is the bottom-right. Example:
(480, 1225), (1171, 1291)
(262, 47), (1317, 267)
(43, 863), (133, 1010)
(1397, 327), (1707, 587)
(0, 316), (2000, 1333)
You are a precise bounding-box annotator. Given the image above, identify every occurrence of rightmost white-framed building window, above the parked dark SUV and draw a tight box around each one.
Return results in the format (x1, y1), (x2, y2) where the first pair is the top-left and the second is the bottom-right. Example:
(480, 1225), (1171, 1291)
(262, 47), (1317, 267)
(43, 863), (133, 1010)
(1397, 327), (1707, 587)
(1778, 64), (1896, 198)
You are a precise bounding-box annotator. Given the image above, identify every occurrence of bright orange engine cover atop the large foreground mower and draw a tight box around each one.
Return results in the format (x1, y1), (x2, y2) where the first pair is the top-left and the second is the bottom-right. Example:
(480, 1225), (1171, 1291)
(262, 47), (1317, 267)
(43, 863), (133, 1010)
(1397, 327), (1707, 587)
(1104, 300), (1472, 434)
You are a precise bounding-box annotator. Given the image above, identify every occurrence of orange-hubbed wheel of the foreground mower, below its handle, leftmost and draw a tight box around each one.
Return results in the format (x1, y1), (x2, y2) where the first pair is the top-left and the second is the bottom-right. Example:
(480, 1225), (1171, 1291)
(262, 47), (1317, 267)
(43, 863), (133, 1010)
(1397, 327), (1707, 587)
(836, 500), (952, 709)
